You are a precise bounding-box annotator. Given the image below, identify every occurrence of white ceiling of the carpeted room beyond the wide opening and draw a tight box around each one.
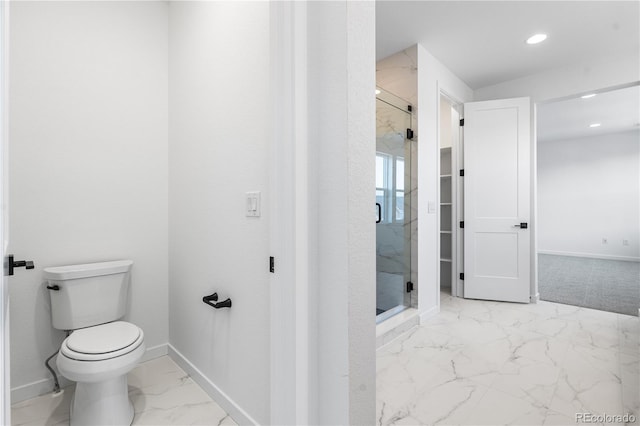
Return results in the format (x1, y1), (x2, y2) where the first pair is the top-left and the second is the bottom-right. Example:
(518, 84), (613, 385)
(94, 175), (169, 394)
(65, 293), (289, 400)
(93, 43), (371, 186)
(536, 86), (640, 142)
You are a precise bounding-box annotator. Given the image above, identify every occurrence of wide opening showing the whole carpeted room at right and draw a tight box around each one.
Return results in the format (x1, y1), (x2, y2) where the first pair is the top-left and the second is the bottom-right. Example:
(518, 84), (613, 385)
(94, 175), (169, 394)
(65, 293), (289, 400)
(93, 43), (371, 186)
(537, 85), (640, 316)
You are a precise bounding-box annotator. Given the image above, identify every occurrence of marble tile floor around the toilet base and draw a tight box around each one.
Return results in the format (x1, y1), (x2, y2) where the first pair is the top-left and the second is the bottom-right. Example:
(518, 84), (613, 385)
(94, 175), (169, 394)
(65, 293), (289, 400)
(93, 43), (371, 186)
(11, 356), (236, 426)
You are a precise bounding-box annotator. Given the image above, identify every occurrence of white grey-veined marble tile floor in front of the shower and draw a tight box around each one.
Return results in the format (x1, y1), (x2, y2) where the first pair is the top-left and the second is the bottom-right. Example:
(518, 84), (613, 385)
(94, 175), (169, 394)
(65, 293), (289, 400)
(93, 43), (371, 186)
(376, 294), (640, 426)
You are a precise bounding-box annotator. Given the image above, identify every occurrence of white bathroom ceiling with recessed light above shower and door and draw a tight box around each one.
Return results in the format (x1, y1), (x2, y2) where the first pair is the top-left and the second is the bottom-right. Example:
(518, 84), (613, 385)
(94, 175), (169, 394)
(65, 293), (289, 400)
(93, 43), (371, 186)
(376, 0), (640, 90)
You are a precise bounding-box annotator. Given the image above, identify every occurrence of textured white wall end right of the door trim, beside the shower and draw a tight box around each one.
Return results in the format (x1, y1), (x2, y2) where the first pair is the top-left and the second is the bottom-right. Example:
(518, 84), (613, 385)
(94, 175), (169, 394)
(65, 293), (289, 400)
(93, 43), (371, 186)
(307, 1), (375, 425)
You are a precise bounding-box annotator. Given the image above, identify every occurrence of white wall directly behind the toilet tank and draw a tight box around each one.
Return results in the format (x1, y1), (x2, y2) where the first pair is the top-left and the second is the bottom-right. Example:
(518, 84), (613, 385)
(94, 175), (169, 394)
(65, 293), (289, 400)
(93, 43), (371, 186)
(9, 2), (168, 402)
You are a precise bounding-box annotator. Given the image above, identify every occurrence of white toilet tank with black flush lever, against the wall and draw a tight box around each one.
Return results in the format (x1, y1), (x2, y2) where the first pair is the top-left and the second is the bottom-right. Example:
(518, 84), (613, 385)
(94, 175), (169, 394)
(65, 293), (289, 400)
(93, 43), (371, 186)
(44, 260), (133, 330)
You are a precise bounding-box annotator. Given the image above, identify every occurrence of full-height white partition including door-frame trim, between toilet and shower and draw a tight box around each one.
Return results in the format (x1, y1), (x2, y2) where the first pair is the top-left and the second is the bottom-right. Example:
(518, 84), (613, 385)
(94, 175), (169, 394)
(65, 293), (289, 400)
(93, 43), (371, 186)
(271, 0), (375, 425)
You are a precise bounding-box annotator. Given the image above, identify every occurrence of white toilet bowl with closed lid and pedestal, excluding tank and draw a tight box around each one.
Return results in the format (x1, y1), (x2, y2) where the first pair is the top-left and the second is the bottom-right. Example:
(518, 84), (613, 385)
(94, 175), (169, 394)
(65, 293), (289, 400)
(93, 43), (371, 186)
(56, 321), (145, 426)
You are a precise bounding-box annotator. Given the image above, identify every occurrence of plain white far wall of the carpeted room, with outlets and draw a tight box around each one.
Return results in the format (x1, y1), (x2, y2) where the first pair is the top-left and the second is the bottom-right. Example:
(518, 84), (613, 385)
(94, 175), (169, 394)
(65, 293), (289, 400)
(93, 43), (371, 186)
(538, 131), (640, 260)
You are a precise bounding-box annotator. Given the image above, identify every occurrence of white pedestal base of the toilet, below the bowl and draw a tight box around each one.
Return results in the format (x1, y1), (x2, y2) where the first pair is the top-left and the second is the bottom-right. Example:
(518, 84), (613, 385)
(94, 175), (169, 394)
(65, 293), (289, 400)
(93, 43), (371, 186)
(70, 374), (134, 426)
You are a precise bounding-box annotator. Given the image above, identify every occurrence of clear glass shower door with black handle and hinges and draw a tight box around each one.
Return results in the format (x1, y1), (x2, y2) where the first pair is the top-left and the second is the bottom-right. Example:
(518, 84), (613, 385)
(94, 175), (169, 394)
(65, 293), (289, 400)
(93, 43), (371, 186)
(376, 91), (411, 322)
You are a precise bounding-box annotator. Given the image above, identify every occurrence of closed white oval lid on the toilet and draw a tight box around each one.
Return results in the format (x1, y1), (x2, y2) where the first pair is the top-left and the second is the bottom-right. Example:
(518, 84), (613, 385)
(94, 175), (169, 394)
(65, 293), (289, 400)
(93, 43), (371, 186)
(66, 321), (142, 354)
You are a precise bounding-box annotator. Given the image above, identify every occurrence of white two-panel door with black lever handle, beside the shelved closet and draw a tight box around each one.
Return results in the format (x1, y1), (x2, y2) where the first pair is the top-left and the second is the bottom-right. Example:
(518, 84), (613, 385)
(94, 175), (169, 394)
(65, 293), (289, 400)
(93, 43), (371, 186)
(464, 98), (531, 302)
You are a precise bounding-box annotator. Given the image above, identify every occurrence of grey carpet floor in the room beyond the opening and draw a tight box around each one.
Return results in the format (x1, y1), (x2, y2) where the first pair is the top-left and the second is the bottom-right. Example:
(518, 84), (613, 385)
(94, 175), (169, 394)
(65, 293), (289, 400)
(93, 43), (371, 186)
(538, 254), (640, 316)
